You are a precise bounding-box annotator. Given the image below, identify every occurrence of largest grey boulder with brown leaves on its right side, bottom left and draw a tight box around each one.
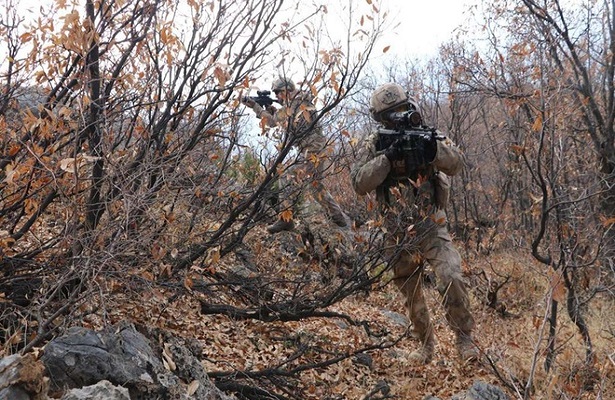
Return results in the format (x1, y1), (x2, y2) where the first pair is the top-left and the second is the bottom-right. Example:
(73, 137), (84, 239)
(41, 323), (236, 400)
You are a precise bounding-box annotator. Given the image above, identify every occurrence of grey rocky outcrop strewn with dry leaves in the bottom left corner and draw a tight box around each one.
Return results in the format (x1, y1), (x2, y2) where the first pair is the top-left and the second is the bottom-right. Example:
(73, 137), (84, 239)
(0, 322), (235, 400)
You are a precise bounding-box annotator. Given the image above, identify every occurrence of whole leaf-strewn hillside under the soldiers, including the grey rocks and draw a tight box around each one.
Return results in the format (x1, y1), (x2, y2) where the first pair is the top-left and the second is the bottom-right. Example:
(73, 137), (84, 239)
(1, 216), (615, 400)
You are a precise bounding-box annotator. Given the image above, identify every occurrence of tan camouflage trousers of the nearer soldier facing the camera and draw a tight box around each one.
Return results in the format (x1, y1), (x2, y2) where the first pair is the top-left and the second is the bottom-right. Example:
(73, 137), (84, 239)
(389, 211), (474, 342)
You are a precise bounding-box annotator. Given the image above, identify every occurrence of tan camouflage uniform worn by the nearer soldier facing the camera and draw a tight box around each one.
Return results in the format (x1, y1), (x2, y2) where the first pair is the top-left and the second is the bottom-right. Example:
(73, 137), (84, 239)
(351, 83), (477, 363)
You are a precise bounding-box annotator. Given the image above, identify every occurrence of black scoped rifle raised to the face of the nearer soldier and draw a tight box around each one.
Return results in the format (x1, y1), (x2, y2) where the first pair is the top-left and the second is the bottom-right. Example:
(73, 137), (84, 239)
(378, 111), (445, 179)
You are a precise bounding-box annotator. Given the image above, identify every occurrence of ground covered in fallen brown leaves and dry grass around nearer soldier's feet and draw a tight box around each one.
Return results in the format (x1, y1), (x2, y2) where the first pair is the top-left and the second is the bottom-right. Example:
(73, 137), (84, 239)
(78, 220), (615, 399)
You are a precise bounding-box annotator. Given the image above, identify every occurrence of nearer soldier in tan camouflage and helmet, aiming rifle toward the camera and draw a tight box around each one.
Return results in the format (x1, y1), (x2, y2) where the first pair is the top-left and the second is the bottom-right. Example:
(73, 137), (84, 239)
(351, 83), (478, 364)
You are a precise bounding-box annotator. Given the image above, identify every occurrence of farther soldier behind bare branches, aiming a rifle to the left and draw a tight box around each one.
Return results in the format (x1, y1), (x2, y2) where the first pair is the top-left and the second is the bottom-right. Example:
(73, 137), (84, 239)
(243, 77), (350, 233)
